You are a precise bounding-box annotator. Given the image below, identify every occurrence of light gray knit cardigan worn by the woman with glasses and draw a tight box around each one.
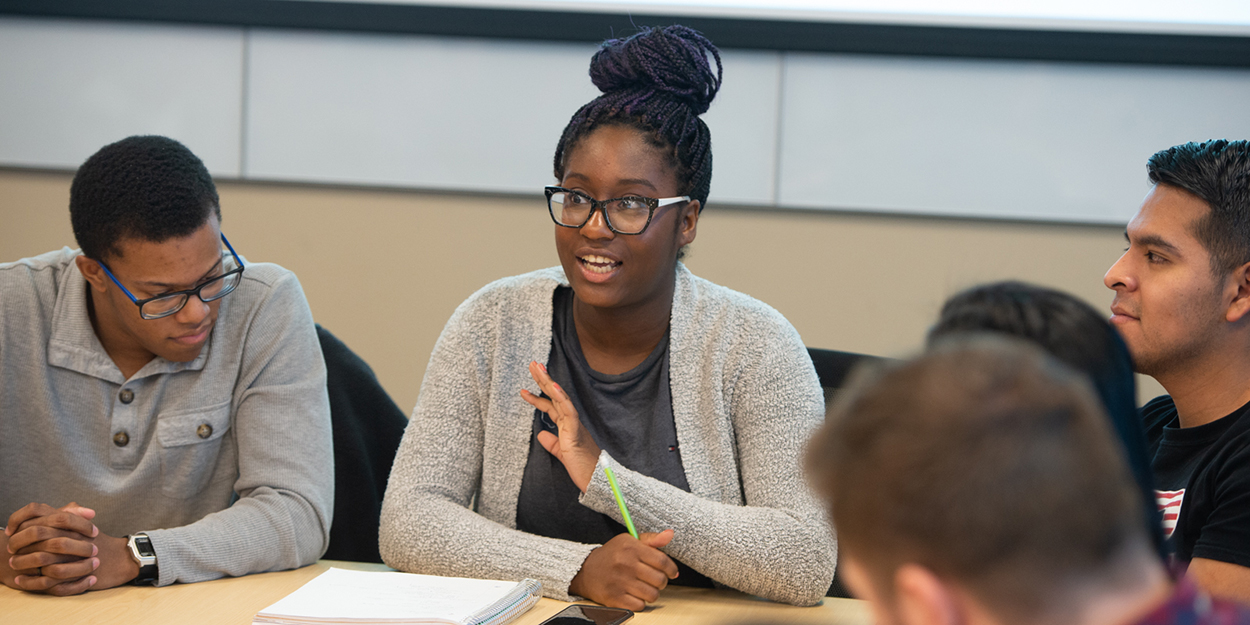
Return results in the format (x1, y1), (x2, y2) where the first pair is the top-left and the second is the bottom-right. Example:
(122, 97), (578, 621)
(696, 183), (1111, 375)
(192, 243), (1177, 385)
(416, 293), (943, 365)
(379, 264), (836, 605)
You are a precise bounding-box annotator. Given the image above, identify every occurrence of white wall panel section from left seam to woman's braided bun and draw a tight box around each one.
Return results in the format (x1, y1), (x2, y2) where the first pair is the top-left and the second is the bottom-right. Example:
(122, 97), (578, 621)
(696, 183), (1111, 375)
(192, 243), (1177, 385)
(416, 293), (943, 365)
(246, 31), (598, 194)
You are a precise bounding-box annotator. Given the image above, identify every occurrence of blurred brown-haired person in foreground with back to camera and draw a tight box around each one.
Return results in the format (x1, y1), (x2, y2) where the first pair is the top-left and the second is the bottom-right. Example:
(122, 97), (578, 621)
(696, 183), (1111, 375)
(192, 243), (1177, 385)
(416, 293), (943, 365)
(808, 335), (1250, 625)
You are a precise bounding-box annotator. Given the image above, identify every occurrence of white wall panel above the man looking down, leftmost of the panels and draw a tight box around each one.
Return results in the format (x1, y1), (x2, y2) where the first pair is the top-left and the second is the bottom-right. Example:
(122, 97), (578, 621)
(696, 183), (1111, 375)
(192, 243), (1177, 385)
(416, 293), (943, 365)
(0, 18), (243, 176)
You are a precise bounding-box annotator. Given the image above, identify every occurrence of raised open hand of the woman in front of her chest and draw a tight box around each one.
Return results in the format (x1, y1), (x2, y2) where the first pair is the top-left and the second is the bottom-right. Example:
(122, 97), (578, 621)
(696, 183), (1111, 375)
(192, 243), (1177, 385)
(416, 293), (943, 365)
(521, 361), (599, 493)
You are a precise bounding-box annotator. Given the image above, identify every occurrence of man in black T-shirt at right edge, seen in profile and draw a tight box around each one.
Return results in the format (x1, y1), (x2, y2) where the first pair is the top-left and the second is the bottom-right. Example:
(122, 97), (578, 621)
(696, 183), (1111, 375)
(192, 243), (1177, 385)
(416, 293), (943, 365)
(1104, 140), (1250, 601)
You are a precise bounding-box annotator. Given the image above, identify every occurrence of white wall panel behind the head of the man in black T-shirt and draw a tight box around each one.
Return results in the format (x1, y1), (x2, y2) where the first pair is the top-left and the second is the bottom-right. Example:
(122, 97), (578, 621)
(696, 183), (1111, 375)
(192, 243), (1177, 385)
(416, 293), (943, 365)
(779, 54), (1250, 223)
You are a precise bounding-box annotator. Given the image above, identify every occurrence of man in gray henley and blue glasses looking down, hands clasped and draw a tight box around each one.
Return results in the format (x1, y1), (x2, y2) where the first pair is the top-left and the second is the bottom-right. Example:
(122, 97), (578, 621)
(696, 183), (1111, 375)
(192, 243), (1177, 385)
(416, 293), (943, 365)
(0, 136), (334, 595)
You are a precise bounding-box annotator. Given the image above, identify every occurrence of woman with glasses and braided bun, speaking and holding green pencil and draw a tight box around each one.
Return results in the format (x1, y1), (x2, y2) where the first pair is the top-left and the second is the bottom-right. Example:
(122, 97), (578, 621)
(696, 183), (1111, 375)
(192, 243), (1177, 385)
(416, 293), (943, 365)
(380, 26), (835, 610)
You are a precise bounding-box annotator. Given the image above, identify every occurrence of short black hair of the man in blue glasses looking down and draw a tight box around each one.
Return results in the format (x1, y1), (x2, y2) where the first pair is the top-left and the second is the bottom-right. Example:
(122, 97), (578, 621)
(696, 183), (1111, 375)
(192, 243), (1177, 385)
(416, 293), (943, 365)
(70, 135), (221, 260)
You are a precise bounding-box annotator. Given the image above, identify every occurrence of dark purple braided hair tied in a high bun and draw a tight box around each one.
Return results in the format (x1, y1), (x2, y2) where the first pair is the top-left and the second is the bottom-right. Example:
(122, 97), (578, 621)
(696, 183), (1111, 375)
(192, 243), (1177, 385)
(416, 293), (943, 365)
(555, 25), (723, 210)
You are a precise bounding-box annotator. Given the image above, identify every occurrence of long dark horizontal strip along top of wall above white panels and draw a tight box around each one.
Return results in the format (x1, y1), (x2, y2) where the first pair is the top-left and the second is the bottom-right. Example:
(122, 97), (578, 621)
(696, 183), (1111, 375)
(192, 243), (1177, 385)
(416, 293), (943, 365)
(0, 0), (1250, 68)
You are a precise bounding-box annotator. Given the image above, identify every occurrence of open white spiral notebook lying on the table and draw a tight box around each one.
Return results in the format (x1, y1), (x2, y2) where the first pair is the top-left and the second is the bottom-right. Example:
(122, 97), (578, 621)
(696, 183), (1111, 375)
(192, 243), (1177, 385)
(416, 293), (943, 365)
(251, 569), (543, 625)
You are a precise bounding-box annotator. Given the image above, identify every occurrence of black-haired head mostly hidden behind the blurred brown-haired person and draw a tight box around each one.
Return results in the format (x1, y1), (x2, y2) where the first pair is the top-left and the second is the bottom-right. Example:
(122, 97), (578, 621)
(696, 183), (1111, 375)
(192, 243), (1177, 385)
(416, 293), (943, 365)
(928, 281), (1164, 554)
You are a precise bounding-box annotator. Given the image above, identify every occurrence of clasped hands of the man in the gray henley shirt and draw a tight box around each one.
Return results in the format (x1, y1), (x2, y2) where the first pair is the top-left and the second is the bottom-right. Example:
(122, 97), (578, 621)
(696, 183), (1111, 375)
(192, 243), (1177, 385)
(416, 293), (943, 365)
(0, 503), (139, 596)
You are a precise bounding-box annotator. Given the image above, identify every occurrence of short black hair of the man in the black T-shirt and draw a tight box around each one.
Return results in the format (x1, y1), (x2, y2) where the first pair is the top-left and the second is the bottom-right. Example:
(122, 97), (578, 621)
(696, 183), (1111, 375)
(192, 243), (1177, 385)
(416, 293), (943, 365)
(1146, 139), (1250, 275)
